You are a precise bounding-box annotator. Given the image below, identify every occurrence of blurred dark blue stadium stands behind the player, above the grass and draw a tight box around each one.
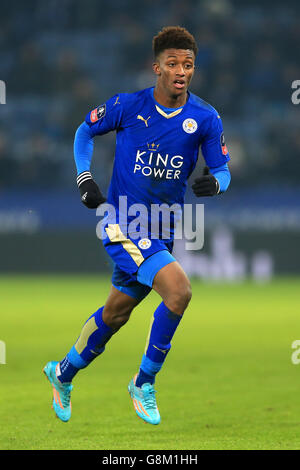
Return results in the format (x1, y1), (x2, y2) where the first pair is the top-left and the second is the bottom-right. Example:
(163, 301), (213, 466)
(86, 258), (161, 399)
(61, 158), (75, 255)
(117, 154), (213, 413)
(0, 0), (300, 280)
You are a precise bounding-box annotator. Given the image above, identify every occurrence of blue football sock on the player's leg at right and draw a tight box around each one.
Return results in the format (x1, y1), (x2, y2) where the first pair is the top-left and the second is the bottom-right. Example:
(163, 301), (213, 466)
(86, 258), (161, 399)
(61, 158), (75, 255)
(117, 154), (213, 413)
(135, 302), (182, 387)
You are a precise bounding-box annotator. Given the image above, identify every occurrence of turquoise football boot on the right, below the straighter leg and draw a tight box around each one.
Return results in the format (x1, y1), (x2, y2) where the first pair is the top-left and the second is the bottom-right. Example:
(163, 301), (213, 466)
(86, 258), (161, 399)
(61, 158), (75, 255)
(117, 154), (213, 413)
(128, 374), (160, 424)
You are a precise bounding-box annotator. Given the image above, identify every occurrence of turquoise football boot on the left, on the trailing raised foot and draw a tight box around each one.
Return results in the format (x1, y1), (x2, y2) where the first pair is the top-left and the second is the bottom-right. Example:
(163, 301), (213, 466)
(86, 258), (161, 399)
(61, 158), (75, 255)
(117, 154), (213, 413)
(43, 361), (73, 422)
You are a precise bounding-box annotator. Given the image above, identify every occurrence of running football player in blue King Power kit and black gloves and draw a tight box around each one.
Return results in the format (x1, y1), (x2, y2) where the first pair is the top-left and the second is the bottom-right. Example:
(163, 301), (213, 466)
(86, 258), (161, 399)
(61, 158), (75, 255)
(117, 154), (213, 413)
(43, 26), (231, 425)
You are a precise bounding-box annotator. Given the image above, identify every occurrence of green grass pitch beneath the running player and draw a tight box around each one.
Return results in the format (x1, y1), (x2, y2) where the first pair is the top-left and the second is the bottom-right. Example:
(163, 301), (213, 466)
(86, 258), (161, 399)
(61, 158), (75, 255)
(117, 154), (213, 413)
(0, 276), (300, 450)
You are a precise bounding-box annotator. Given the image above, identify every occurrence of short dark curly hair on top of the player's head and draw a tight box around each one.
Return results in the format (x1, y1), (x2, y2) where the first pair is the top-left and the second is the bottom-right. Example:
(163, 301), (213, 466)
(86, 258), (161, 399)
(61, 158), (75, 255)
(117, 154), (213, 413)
(152, 26), (198, 58)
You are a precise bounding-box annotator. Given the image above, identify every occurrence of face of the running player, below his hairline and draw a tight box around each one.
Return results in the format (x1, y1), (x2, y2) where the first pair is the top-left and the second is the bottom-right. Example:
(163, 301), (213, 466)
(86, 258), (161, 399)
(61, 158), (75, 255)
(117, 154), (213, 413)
(153, 49), (195, 97)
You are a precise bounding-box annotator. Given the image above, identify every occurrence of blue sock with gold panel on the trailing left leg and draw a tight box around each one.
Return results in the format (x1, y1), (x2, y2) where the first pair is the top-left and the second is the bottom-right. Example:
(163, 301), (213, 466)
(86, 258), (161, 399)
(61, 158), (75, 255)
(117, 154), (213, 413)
(57, 307), (115, 382)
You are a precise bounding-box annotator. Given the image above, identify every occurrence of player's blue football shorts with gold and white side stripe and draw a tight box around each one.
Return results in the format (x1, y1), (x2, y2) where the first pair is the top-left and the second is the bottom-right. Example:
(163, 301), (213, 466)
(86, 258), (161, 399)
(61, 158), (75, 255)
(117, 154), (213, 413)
(103, 224), (176, 300)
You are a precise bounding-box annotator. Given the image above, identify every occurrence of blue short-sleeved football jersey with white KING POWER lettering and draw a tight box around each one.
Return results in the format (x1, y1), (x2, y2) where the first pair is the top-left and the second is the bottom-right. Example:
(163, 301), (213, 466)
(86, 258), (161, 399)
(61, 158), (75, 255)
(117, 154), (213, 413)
(86, 87), (229, 212)
